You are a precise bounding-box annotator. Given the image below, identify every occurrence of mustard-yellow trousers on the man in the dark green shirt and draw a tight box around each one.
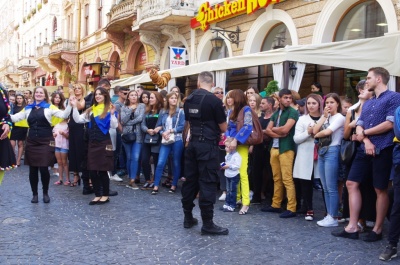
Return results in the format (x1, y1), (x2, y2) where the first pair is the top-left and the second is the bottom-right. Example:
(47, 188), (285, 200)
(270, 148), (296, 210)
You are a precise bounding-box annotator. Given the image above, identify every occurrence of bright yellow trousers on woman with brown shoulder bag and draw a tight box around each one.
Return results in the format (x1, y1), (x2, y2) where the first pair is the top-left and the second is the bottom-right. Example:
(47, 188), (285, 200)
(236, 145), (250, 206)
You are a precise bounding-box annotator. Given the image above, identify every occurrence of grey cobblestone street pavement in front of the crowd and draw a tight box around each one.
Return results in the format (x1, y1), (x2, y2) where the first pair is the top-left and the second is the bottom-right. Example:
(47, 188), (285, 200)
(0, 166), (390, 264)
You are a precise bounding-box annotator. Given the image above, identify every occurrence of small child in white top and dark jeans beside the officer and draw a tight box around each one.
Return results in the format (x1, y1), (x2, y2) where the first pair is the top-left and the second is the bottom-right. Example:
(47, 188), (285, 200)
(221, 139), (242, 212)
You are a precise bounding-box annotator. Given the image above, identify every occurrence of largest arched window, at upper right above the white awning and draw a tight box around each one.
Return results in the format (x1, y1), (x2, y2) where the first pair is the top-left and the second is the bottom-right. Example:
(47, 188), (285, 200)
(335, 1), (388, 41)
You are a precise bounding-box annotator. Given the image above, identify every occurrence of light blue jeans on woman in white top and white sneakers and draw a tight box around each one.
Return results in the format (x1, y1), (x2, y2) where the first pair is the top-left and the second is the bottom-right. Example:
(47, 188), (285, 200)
(318, 145), (340, 217)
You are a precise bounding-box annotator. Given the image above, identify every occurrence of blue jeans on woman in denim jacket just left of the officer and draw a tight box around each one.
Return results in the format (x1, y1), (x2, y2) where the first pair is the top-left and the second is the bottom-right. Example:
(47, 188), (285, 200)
(154, 140), (183, 187)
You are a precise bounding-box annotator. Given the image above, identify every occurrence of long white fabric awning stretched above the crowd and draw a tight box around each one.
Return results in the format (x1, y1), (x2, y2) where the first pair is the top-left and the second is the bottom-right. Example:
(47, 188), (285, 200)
(112, 33), (400, 87)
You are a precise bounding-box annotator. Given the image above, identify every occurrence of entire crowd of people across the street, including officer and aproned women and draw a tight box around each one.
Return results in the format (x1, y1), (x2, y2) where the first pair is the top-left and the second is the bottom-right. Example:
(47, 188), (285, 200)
(0, 67), (400, 260)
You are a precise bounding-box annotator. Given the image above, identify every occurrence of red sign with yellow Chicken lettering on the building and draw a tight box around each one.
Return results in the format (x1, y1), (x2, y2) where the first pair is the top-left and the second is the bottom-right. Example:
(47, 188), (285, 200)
(190, 0), (282, 31)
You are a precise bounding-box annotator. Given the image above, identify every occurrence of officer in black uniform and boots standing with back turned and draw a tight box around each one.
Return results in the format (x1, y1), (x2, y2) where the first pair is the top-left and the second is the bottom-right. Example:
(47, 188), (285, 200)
(182, 72), (229, 235)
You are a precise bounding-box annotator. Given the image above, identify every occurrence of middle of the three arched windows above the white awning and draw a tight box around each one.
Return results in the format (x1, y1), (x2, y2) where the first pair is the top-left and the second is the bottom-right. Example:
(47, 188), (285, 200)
(261, 23), (292, 51)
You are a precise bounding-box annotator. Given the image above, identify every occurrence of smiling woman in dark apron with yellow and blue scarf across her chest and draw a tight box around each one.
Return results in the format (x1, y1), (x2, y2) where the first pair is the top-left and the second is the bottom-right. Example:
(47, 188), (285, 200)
(70, 87), (118, 205)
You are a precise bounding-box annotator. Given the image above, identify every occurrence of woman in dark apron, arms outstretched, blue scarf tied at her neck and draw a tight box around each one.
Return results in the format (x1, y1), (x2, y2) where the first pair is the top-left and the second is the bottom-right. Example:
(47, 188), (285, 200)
(11, 87), (71, 203)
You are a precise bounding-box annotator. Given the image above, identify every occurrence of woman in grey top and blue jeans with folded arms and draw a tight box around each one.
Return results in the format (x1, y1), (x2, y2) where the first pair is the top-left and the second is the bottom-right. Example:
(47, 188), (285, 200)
(121, 90), (146, 190)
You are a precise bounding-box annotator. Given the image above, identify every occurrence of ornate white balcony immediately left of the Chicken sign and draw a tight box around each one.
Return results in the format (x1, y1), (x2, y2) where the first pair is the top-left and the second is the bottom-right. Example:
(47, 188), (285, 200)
(133, 0), (196, 30)
